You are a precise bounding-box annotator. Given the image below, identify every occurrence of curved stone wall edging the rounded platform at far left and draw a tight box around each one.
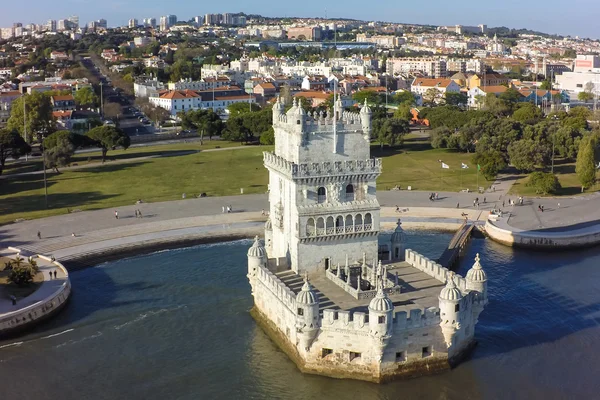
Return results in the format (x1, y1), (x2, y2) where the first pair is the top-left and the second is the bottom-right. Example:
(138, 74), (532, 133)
(0, 255), (71, 336)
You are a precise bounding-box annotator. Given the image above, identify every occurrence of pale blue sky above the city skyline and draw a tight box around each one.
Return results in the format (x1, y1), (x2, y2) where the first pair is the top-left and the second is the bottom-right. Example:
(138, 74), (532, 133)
(0, 0), (600, 39)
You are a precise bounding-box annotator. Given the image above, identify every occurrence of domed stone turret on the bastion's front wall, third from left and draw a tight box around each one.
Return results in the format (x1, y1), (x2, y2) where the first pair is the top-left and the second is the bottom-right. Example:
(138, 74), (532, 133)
(369, 280), (394, 363)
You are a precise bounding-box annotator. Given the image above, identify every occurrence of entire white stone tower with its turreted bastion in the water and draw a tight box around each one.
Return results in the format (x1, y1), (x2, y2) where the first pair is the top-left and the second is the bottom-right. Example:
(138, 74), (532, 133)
(248, 96), (487, 382)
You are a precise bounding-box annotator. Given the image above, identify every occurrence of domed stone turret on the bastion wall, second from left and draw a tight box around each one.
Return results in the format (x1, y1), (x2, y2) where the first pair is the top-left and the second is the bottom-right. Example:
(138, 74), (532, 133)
(296, 275), (320, 351)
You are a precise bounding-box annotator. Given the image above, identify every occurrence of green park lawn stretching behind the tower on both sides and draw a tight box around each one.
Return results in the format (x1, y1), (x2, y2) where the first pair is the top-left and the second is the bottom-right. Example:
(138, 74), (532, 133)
(0, 134), (600, 223)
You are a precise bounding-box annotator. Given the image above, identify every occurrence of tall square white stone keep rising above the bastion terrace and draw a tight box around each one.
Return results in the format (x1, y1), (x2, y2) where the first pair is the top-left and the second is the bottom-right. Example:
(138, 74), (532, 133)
(264, 99), (381, 273)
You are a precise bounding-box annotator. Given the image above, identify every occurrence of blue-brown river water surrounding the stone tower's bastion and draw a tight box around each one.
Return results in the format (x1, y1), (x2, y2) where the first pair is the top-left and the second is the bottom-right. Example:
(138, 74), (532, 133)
(0, 232), (600, 400)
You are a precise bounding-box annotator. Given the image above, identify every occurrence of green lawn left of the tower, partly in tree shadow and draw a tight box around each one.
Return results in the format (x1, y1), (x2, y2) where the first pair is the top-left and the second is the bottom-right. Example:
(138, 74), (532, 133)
(0, 143), (268, 223)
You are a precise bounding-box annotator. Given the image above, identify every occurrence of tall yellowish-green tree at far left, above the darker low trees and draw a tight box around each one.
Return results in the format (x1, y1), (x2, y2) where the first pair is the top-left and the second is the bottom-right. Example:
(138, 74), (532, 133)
(6, 92), (56, 143)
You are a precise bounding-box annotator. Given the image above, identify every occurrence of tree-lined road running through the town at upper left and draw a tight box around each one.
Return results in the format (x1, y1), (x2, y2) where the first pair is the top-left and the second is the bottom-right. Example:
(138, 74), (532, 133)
(81, 58), (153, 136)
